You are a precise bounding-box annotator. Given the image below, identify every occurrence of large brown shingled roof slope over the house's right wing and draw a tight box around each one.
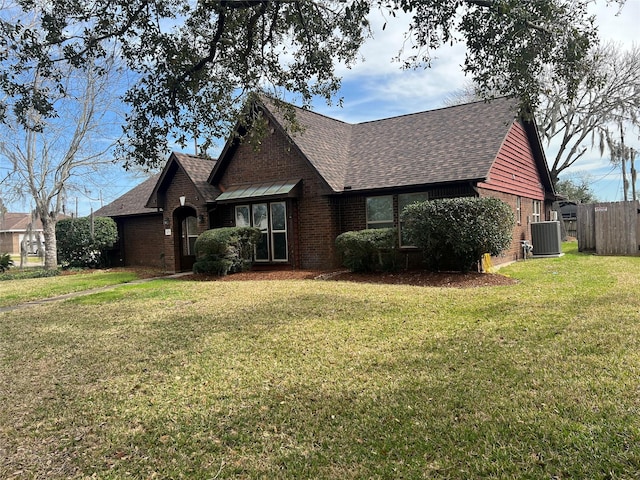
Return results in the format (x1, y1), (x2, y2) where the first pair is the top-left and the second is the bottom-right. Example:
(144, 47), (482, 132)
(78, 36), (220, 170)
(264, 98), (518, 192)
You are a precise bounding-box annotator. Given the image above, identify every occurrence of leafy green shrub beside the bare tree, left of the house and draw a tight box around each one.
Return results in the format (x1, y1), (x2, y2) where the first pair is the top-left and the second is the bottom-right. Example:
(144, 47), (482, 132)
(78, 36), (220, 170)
(56, 217), (118, 268)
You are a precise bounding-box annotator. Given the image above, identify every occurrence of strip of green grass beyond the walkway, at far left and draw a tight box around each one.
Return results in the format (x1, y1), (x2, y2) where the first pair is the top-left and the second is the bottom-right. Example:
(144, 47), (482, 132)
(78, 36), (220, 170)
(0, 269), (136, 307)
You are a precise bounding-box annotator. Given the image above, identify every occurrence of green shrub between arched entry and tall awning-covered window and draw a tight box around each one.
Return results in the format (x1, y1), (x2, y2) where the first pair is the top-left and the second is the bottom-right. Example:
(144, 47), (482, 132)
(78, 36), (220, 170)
(193, 227), (261, 276)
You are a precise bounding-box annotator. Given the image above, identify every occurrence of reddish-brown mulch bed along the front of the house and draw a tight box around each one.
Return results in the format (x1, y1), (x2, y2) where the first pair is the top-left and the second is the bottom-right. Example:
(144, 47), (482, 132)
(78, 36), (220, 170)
(180, 270), (516, 288)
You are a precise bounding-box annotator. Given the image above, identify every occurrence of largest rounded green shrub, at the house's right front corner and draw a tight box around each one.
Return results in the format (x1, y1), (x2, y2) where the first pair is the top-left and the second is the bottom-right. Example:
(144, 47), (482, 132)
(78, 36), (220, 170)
(401, 198), (515, 271)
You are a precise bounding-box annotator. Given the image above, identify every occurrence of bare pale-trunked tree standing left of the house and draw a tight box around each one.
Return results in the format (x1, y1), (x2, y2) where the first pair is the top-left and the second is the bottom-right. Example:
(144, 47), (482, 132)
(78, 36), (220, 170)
(0, 53), (122, 269)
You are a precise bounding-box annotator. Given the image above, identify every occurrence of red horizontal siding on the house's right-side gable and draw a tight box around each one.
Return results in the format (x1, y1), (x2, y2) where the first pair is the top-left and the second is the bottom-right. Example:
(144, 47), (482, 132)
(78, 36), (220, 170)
(478, 121), (545, 200)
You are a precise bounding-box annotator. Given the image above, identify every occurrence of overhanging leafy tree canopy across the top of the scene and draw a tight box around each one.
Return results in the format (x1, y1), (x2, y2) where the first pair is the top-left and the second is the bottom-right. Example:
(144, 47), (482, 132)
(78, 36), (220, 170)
(0, 0), (624, 169)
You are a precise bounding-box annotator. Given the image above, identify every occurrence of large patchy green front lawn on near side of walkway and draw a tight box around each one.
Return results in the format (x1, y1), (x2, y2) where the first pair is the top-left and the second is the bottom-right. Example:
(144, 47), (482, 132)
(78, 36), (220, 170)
(0, 246), (640, 479)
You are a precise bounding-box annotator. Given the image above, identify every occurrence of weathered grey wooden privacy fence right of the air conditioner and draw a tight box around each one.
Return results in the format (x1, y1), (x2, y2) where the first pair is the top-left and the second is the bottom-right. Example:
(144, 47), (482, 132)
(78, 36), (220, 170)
(576, 201), (640, 255)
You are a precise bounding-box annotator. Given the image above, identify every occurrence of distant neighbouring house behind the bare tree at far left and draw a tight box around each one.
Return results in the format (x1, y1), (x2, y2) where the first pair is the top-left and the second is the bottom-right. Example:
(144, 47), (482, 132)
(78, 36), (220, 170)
(0, 213), (44, 255)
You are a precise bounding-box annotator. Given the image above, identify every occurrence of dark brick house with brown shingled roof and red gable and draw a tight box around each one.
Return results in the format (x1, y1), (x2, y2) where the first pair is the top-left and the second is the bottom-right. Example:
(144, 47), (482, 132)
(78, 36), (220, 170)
(96, 98), (556, 271)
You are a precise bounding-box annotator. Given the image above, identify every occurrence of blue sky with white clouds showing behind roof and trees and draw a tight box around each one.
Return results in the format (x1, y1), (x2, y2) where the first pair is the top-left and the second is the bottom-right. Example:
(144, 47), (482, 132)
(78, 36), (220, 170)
(2, 0), (640, 216)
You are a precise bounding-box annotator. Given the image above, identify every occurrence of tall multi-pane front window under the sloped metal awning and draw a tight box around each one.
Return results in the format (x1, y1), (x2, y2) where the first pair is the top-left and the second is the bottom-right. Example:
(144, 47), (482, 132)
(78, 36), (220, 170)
(235, 202), (289, 262)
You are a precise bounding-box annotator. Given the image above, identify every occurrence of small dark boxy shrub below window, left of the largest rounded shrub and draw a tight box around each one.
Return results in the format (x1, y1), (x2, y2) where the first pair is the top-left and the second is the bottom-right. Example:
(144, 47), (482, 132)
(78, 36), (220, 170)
(336, 228), (398, 272)
